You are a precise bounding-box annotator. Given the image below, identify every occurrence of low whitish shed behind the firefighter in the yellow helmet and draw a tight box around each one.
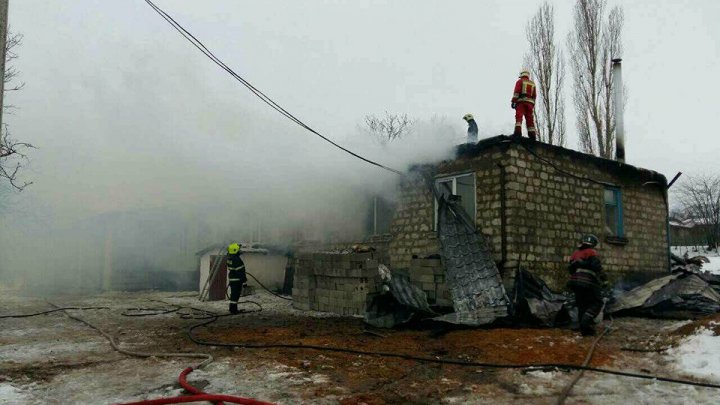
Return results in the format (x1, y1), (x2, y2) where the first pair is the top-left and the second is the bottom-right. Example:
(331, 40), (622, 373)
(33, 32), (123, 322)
(195, 245), (288, 301)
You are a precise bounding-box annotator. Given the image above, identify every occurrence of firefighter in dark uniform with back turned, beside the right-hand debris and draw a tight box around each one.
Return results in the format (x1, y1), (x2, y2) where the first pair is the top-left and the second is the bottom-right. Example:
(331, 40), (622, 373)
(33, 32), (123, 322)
(568, 235), (607, 336)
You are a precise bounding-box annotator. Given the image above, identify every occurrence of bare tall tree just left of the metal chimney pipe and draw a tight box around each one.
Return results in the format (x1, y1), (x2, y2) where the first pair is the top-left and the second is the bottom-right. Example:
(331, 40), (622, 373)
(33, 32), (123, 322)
(567, 0), (624, 158)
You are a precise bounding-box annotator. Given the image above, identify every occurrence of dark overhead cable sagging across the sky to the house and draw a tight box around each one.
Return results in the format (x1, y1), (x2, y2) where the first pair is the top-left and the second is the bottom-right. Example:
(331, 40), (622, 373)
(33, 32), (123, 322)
(145, 0), (402, 175)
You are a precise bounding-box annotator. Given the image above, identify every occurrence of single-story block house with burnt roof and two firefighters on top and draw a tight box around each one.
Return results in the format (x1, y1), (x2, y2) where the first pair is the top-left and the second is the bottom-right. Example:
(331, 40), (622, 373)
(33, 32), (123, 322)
(389, 135), (669, 290)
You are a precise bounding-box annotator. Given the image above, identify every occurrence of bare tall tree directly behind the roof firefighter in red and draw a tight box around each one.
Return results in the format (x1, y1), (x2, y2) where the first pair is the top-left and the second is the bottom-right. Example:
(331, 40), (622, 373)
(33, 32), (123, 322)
(525, 2), (565, 145)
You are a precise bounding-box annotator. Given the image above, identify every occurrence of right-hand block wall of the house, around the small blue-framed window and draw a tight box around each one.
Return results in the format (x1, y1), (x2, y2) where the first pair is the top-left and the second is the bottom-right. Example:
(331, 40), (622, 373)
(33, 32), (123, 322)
(506, 144), (667, 289)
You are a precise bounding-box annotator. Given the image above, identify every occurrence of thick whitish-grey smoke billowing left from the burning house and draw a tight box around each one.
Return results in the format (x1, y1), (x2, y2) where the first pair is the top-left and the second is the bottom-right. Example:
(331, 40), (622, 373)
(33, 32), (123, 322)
(0, 38), (464, 292)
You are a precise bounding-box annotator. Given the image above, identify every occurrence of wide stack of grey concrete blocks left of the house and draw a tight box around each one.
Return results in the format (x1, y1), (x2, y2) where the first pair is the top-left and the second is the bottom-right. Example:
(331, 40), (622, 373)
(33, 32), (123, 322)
(293, 252), (378, 315)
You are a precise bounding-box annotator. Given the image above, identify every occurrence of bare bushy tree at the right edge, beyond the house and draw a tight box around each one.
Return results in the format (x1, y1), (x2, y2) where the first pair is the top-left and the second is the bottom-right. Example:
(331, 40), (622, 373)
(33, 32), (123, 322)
(675, 175), (720, 249)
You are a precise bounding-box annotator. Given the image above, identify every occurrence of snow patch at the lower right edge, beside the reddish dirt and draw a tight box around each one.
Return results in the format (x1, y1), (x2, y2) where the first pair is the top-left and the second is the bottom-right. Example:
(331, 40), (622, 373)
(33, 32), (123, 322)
(668, 322), (720, 382)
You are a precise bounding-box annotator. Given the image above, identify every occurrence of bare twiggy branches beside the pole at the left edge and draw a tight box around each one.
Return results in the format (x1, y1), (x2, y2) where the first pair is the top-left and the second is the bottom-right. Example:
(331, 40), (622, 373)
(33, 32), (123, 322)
(0, 34), (34, 191)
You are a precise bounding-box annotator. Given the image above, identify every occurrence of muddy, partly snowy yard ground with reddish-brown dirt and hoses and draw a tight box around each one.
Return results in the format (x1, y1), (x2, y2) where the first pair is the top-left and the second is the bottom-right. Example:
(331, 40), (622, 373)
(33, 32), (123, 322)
(0, 292), (718, 404)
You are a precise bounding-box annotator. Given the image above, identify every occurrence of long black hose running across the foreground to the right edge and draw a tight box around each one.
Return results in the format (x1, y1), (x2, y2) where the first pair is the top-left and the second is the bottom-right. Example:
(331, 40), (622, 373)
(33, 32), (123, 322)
(185, 312), (720, 389)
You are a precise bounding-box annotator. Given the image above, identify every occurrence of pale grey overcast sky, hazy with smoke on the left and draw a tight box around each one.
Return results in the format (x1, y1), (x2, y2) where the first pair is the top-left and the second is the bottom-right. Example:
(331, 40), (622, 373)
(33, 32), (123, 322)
(5, 0), (720, 221)
